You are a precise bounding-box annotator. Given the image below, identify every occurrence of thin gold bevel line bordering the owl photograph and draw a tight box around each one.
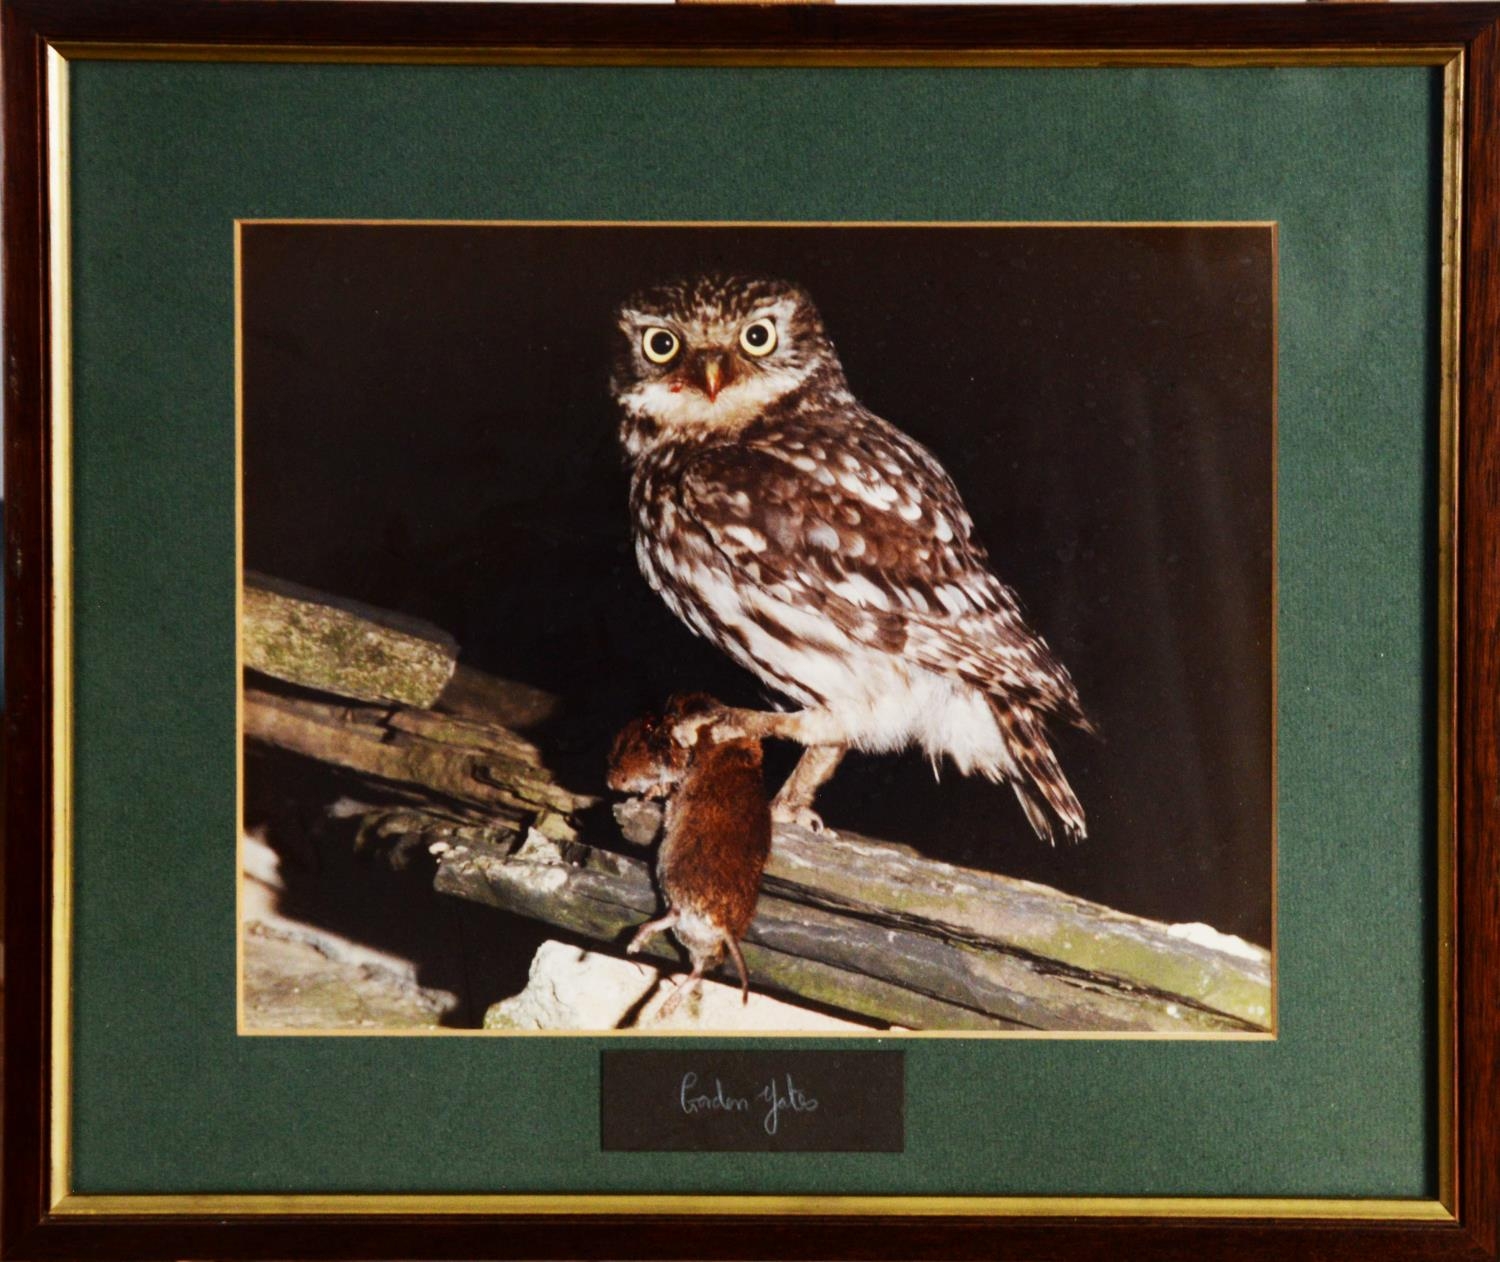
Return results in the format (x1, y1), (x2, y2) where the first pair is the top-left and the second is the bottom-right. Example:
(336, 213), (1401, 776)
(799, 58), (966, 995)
(234, 218), (1280, 1043)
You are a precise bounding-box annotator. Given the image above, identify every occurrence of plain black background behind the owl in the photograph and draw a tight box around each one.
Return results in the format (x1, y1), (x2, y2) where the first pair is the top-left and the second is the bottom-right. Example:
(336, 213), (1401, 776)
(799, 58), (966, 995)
(242, 224), (1275, 945)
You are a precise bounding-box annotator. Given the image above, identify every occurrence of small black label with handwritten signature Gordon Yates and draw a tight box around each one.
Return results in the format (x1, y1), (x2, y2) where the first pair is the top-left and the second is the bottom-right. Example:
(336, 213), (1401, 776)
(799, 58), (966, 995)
(599, 1047), (906, 1152)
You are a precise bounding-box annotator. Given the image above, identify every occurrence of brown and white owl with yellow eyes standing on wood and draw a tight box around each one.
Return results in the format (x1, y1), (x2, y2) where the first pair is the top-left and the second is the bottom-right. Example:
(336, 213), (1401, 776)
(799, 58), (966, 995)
(611, 275), (1092, 842)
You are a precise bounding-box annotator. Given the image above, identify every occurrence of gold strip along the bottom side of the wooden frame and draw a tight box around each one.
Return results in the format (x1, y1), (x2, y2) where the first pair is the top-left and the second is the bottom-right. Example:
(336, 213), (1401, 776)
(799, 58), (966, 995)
(51, 1194), (1454, 1223)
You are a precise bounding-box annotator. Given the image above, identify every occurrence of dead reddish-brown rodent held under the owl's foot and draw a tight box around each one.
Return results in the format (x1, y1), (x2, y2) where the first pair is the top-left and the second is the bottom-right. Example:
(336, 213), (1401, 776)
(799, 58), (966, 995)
(609, 693), (771, 1014)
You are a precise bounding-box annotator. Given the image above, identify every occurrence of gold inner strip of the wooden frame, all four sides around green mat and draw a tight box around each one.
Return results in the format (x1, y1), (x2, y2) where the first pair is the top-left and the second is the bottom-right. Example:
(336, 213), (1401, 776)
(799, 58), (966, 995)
(47, 44), (1464, 1223)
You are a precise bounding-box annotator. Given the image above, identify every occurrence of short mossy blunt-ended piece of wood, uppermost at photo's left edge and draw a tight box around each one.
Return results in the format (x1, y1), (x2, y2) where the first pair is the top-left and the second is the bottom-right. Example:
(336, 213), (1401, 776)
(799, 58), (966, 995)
(240, 572), (459, 708)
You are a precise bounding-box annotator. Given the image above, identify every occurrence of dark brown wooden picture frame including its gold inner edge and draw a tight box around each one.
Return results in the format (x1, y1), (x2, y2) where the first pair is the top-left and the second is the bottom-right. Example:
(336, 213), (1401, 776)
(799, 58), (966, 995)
(0, 0), (1500, 1259)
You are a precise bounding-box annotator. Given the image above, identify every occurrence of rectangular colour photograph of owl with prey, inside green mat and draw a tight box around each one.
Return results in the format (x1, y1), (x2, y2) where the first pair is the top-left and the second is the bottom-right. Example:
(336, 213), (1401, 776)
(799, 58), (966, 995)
(237, 221), (1277, 1038)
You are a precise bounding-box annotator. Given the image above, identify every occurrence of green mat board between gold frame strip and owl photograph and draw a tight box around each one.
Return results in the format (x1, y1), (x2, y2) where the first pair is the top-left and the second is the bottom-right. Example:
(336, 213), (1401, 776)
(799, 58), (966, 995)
(61, 62), (1442, 1197)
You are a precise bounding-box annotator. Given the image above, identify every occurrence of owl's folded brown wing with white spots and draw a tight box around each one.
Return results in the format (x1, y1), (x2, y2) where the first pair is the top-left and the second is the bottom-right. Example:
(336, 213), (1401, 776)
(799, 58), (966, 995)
(680, 417), (1088, 726)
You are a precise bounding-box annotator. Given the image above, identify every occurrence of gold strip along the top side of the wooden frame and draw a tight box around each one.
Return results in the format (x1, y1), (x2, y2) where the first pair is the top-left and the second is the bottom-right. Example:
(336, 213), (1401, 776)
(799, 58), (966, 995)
(53, 41), (1463, 69)
